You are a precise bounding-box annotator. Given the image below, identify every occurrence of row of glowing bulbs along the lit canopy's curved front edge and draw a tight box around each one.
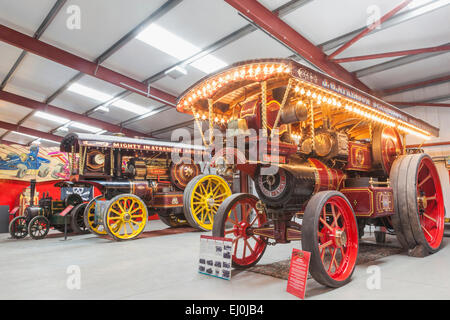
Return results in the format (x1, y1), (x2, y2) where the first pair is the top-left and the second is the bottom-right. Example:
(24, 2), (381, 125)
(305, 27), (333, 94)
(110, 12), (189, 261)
(180, 63), (291, 107)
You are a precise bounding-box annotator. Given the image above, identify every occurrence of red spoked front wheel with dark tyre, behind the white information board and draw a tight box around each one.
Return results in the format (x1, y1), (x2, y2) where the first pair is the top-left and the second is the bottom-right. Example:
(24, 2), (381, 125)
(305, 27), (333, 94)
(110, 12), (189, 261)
(213, 193), (267, 268)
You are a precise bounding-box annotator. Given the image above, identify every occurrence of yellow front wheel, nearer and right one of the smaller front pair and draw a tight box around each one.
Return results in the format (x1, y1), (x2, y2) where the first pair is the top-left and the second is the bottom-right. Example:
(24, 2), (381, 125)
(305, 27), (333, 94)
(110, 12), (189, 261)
(103, 194), (148, 240)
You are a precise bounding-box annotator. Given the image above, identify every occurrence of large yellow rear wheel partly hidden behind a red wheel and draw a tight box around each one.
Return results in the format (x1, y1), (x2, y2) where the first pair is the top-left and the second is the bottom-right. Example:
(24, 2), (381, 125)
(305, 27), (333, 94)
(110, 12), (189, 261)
(183, 174), (231, 231)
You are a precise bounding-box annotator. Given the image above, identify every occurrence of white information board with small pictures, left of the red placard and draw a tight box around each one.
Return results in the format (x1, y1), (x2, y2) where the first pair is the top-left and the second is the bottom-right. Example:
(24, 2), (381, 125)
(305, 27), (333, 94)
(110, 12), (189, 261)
(198, 236), (232, 280)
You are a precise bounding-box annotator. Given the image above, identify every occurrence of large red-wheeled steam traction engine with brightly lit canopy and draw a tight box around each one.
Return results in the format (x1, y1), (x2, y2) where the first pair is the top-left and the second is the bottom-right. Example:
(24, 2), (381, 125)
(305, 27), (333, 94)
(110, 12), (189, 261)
(177, 59), (444, 287)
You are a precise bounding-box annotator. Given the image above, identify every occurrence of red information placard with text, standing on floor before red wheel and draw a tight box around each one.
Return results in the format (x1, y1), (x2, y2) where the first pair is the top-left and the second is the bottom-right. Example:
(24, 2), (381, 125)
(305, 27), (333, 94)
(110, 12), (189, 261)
(286, 249), (311, 299)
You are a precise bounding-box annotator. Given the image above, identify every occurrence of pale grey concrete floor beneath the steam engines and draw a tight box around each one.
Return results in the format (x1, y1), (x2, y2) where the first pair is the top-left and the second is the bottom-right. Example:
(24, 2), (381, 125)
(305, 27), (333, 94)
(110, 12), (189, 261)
(0, 221), (450, 300)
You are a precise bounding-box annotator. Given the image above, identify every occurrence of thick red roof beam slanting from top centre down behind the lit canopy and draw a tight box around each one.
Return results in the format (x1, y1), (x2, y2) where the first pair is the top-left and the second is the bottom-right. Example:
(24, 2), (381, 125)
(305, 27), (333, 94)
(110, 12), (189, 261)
(225, 0), (371, 93)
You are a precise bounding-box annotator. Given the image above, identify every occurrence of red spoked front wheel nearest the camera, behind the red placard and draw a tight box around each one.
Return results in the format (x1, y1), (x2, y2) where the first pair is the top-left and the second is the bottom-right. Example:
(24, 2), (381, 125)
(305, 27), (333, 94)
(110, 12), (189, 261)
(302, 191), (358, 288)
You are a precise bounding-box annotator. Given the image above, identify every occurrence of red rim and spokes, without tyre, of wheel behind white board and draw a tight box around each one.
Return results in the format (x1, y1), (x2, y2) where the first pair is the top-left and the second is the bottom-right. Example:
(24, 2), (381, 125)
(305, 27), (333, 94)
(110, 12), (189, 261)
(224, 198), (267, 266)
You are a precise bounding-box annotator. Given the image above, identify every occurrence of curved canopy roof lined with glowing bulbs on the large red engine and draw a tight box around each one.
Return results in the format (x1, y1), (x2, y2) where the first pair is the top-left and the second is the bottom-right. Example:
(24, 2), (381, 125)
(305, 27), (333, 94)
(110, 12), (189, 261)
(177, 59), (439, 139)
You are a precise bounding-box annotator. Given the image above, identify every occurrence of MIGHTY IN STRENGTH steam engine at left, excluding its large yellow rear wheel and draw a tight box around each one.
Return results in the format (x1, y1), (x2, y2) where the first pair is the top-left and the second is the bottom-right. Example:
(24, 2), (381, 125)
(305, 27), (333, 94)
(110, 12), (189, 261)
(61, 134), (205, 240)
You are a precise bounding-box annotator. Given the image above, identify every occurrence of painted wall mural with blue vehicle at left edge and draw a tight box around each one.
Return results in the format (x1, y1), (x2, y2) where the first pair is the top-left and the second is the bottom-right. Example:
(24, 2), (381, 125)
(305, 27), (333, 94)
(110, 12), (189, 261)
(0, 145), (70, 182)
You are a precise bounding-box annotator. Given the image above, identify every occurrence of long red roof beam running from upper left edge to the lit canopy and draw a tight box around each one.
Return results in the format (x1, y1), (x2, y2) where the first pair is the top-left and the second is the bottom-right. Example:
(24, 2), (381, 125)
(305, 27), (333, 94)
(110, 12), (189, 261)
(0, 25), (176, 107)
